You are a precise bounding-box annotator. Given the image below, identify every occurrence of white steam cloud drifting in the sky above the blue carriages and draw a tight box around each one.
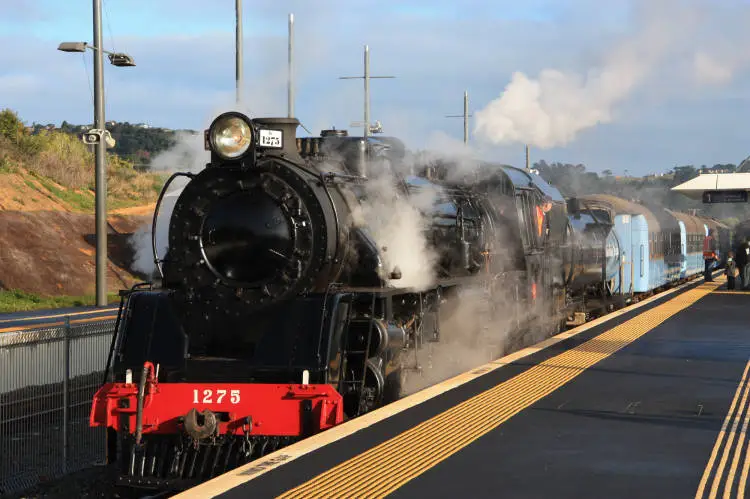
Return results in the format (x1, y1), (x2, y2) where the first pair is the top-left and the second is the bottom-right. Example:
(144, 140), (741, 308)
(474, 0), (746, 149)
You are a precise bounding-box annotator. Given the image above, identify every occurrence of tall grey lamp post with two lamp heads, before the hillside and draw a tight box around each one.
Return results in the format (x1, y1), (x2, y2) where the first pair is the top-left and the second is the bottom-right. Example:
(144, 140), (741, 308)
(57, 0), (135, 307)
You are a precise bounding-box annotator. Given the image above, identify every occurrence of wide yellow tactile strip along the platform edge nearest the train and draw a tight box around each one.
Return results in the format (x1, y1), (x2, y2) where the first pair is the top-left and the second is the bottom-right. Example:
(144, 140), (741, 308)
(279, 280), (724, 499)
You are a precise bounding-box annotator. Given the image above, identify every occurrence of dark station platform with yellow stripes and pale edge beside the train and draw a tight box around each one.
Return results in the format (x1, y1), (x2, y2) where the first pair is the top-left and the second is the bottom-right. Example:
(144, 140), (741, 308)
(175, 276), (750, 499)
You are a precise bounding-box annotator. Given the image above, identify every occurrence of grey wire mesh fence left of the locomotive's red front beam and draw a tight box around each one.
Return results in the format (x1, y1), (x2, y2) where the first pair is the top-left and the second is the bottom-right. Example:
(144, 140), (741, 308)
(0, 320), (115, 497)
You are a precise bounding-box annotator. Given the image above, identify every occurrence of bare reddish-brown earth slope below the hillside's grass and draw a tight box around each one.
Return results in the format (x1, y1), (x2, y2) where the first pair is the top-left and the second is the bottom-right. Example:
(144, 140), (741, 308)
(0, 172), (153, 306)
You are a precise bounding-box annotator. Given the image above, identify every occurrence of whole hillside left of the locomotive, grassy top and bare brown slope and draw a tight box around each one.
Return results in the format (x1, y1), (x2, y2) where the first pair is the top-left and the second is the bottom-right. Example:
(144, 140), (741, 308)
(0, 109), (166, 313)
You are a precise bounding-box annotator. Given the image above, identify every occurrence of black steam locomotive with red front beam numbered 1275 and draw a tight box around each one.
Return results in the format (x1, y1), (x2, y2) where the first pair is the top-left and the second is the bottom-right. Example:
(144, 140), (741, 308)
(90, 112), (712, 489)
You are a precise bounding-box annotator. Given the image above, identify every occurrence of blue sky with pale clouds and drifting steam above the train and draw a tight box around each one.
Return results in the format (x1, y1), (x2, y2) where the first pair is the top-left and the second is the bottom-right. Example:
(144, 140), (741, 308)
(0, 0), (750, 174)
